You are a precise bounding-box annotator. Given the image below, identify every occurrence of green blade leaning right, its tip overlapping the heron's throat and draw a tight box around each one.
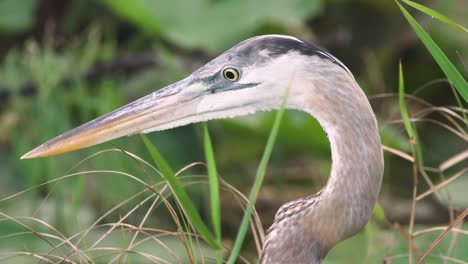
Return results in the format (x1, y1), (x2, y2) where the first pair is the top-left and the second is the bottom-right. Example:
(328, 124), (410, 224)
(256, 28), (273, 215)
(227, 79), (292, 264)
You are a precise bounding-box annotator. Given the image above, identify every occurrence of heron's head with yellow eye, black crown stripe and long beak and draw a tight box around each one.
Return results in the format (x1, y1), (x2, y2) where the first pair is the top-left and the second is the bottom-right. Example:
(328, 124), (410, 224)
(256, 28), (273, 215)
(22, 35), (346, 158)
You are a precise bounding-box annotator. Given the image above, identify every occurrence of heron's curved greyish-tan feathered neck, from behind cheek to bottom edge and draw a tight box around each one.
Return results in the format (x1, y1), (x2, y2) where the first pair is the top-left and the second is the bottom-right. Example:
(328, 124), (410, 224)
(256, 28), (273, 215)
(261, 56), (383, 264)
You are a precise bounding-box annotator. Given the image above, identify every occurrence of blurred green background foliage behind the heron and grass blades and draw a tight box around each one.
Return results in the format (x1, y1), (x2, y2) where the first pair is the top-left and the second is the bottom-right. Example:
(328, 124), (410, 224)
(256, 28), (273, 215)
(0, 0), (468, 263)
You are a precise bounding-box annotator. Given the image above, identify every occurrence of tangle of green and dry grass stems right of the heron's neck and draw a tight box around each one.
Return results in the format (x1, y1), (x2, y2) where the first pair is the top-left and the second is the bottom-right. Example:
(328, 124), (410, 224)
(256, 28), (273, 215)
(378, 86), (468, 263)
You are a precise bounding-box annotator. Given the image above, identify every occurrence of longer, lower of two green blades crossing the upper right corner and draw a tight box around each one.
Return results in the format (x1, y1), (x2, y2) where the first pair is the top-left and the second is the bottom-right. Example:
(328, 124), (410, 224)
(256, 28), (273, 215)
(395, 1), (468, 102)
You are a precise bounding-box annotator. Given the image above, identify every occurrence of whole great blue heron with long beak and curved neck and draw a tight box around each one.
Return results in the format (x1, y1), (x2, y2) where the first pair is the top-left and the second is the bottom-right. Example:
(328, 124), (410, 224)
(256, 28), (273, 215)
(22, 35), (384, 264)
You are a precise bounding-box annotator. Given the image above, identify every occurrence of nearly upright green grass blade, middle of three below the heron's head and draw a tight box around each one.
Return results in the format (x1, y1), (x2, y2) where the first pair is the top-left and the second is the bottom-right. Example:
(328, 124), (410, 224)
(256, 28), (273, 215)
(203, 124), (221, 256)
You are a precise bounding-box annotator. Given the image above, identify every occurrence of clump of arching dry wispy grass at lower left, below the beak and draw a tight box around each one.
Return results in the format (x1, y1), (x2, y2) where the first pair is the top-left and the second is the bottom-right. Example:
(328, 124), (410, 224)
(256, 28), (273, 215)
(0, 150), (218, 263)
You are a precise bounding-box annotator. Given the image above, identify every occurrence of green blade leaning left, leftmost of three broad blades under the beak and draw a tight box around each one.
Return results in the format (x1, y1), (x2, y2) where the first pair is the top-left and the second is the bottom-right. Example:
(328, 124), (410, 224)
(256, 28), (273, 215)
(141, 134), (221, 249)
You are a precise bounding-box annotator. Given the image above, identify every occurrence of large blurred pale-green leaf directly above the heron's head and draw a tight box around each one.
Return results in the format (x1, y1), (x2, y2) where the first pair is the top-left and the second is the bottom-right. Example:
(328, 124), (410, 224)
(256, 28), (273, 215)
(101, 0), (322, 52)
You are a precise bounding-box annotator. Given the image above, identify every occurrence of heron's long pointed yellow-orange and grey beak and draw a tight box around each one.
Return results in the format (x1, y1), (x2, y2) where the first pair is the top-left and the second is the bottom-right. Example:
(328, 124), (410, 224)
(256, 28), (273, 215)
(21, 77), (203, 159)
